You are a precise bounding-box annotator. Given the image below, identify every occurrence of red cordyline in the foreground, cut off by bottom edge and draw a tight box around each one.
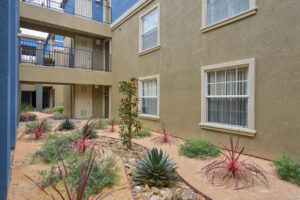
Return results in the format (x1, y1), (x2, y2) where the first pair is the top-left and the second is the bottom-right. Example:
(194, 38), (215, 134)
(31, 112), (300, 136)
(24, 149), (127, 200)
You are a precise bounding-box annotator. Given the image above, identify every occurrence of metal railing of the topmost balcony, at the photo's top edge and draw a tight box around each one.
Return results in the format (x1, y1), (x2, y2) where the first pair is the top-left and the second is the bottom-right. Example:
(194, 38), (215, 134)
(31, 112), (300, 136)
(20, 0), (111, 24)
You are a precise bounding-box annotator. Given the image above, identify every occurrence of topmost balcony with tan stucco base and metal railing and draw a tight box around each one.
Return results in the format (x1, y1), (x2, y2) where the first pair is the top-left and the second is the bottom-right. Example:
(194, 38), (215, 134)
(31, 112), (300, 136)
(19, 0), (111, 38)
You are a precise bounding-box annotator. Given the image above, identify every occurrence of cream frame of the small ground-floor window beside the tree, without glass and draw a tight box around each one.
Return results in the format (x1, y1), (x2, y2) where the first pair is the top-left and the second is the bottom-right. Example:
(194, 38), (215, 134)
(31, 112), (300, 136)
(139, 75), (160, 119)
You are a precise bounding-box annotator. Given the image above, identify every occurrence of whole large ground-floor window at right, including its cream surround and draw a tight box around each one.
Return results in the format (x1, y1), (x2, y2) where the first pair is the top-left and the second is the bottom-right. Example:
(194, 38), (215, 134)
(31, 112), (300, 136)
(201, 59), (254, 136)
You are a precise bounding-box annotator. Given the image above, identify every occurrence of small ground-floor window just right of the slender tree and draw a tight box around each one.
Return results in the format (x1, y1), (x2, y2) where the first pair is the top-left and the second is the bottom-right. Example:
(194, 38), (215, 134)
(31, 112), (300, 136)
(139, 76), (159, 117)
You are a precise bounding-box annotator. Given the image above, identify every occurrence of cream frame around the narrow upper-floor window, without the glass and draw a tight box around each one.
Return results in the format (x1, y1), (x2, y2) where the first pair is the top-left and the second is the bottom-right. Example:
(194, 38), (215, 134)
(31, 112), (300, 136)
(138, 3), (160, 56)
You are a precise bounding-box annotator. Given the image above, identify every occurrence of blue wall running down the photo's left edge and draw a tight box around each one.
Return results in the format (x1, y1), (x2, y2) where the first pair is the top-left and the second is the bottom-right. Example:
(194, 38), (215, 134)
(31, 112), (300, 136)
(0, 1), (18, 200)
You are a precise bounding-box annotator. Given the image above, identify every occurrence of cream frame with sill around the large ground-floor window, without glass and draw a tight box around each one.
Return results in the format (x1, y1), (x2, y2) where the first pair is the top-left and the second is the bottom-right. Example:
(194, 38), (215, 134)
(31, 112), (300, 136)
(199, 58), (256, 137)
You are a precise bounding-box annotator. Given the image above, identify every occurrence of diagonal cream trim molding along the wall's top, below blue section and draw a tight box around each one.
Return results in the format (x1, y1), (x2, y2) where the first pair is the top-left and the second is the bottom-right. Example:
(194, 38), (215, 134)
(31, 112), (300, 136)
(110, 0), (153, 30)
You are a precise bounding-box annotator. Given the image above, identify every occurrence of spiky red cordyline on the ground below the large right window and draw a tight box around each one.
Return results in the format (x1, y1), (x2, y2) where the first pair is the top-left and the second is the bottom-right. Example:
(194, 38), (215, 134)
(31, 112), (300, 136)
(202, 135), (269, 189)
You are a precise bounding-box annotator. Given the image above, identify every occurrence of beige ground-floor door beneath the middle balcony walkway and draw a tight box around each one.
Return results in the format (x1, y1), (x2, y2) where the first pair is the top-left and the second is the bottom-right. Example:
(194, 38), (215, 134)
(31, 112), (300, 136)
(75, 85), (93, 118)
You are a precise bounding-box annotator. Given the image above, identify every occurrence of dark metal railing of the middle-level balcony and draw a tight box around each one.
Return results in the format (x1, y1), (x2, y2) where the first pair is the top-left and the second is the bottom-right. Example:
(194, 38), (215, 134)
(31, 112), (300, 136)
(19, 39), (111, 72)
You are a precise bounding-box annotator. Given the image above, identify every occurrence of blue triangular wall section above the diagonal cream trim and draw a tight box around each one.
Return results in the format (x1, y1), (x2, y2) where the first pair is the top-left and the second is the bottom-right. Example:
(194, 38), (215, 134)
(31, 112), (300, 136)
(111, 0), (139, 22)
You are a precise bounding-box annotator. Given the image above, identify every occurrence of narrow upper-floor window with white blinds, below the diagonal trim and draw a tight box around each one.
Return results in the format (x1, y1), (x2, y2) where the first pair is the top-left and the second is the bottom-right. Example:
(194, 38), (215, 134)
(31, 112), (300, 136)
(140, 5), (159, 52)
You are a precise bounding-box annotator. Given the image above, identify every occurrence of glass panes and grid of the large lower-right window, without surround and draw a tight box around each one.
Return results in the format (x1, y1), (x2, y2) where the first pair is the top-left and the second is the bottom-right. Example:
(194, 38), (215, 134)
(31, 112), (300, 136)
(206, 67), (249, 127)
